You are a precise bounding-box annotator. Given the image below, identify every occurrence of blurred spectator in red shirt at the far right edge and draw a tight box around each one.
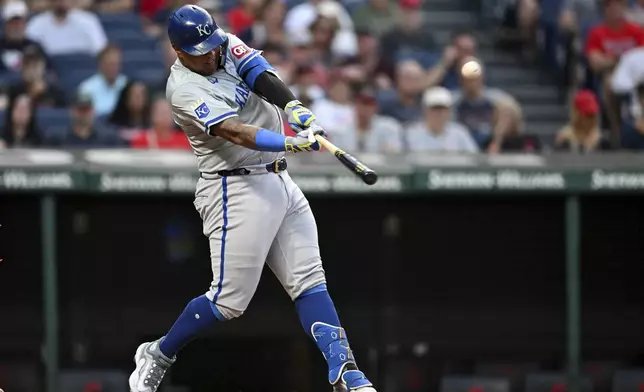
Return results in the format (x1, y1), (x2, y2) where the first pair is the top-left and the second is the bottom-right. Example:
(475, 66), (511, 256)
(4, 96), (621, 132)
(586, 0), (644, 135)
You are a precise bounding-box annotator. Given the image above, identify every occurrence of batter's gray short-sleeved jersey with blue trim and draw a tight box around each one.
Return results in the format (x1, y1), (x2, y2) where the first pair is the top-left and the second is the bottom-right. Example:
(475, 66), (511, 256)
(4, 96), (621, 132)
(166, 34), (284, 173)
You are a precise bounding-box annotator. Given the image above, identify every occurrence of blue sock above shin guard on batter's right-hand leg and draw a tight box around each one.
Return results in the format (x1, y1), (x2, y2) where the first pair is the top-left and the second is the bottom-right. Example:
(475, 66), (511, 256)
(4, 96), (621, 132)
(295, 284), (340, 339)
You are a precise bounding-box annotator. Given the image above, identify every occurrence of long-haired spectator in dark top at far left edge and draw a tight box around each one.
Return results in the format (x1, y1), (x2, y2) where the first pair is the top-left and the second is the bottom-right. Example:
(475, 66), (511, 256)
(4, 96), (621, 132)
(0, 94), (42, 148)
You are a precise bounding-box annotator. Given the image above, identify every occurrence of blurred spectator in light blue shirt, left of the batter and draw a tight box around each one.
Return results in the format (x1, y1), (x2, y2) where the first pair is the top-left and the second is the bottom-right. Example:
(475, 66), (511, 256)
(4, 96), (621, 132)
(79, 44), (127, 117)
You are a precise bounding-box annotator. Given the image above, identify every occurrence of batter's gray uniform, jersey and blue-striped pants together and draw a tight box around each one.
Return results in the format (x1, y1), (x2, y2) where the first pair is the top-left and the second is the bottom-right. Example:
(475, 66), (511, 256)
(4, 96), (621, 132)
(166, 34), (326, 318)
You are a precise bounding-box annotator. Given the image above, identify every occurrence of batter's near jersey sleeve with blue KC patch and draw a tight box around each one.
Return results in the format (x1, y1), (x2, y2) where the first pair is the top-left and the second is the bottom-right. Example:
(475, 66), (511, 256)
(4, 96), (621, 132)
(171, 84), (238, 134)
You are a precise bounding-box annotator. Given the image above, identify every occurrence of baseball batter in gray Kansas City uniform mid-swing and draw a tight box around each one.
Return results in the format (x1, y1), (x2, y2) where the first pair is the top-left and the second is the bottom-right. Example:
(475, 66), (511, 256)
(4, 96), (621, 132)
(129, 5), (375, 392)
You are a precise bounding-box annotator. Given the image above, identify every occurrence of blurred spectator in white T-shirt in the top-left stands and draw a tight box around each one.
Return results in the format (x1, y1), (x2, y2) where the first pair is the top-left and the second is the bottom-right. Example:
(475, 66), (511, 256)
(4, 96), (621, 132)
(27, 0), (107, 56)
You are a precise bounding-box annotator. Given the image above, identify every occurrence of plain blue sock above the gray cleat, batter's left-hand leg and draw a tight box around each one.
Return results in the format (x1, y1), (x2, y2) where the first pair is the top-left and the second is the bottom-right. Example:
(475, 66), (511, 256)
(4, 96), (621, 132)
(159, 294), (224, 358)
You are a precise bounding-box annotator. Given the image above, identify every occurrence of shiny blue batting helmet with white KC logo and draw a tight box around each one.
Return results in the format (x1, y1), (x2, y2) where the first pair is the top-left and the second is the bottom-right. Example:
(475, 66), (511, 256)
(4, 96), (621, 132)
(168, 5), (228, 56)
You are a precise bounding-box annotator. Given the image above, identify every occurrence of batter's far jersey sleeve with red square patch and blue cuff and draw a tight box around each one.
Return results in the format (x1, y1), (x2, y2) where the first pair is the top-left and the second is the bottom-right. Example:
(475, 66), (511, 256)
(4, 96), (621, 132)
(228, 34), (277, 89)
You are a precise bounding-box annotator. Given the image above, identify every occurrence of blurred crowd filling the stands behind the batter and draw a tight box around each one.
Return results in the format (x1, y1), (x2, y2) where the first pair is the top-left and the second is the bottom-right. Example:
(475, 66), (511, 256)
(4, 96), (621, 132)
(0, 0), (644, 153)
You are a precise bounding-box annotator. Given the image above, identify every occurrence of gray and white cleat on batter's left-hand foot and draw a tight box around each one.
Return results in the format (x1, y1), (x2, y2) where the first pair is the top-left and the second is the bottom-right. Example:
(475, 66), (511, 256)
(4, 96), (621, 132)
(129, 339), (177, 392)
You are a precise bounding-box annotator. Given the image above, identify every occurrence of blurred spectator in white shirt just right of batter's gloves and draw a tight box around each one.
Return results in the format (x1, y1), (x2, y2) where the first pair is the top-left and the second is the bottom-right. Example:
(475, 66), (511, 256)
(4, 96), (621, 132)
(311, 75), (354, 138)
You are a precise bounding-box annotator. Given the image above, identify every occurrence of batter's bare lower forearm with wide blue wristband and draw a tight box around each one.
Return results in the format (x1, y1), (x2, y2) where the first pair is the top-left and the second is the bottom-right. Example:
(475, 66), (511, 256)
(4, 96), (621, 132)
(210, 118), (286, 152)
